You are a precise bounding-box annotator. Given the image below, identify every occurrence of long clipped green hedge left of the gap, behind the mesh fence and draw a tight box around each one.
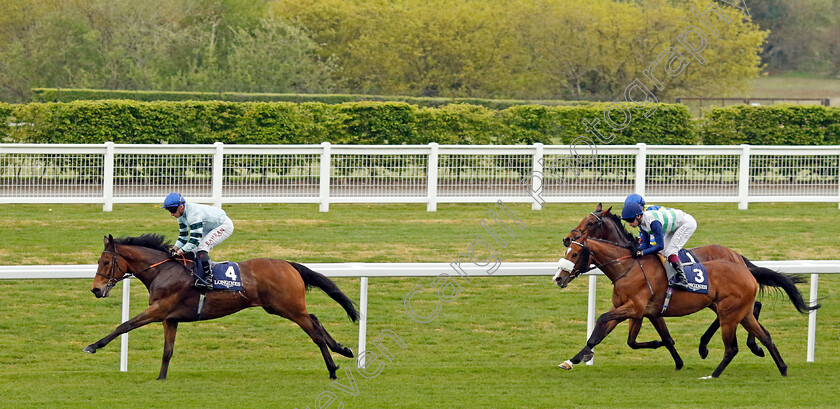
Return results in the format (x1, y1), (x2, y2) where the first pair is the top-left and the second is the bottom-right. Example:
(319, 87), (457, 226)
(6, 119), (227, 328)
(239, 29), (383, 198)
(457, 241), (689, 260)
(0, 100), (698, 144)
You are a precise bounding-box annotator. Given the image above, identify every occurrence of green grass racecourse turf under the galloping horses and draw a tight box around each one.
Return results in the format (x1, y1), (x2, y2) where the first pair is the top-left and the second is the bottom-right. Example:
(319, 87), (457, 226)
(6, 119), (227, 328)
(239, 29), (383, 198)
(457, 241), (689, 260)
(0, 203), (840, 409)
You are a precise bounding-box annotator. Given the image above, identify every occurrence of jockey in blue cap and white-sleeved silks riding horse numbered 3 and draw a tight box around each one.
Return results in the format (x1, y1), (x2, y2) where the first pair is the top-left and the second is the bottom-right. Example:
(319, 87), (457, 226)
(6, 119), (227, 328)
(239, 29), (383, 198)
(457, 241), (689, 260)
(621, 203), (697, 289)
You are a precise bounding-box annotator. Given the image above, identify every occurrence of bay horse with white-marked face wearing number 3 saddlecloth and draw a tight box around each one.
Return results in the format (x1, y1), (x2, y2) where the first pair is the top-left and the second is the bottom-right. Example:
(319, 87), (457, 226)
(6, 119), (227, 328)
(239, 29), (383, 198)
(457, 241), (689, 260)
(554, 231), (819, 378)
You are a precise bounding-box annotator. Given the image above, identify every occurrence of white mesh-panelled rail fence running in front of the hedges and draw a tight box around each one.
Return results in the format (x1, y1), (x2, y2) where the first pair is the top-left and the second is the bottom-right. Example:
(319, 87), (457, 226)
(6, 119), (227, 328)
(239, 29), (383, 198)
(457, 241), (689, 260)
(0, 142), (840, 211)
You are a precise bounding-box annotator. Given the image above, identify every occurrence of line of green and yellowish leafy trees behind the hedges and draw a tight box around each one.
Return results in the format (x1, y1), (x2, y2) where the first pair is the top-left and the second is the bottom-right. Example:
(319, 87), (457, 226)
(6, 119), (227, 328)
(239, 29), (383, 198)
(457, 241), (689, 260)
(0, 0), (830, 102)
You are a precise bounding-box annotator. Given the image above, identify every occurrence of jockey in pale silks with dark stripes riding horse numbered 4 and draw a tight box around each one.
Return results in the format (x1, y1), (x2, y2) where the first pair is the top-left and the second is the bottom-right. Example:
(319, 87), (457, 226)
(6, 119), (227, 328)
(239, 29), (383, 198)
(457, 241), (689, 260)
(161, 193), (233, 290)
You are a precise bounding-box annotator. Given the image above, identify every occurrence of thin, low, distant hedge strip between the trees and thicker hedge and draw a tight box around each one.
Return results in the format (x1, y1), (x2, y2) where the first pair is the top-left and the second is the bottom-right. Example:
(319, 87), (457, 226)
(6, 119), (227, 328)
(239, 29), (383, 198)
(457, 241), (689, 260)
(32, 88), (590, 109)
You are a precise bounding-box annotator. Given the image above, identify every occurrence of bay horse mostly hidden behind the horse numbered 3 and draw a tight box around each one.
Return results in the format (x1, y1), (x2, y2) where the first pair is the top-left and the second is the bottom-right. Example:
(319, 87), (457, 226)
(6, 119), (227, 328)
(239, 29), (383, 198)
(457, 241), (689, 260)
(563, 203), (804, 358)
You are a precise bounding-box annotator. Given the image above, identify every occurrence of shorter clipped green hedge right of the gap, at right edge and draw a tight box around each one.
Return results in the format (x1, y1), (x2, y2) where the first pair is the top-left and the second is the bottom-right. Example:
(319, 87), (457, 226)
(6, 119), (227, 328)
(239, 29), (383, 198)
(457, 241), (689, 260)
(701, 104), (840, 145)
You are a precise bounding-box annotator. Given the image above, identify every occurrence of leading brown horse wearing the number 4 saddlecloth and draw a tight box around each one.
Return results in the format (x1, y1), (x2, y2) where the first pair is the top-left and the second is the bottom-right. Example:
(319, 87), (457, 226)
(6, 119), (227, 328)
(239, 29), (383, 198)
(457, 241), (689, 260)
(84, 234), (358, 379)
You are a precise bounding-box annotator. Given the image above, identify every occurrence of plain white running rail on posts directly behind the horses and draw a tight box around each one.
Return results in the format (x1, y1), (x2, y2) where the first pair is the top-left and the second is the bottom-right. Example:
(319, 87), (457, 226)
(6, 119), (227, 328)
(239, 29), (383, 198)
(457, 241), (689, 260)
(0, 260), (828, 372)
